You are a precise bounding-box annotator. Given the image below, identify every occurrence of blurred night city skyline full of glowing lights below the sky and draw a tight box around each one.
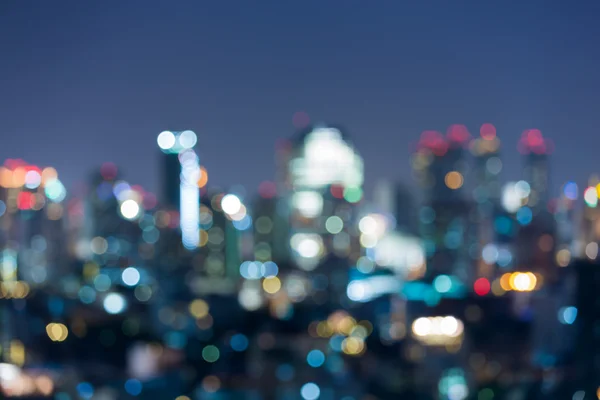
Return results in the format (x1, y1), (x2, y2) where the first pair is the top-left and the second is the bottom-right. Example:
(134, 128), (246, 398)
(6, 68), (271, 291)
(0, 123), (600, 400)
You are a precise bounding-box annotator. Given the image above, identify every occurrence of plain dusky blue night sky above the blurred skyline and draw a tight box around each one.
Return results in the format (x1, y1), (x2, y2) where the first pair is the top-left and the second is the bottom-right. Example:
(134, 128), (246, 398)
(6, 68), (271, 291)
(0, 0), (600, 198)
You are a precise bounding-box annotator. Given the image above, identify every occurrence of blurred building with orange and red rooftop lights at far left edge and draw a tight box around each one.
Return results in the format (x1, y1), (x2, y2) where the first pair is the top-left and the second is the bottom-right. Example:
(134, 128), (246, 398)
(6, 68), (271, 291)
(0, 159), (68, 366)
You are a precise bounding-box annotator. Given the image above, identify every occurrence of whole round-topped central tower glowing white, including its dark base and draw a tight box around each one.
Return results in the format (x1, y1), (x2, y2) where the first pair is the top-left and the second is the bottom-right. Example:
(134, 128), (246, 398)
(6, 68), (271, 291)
(277, 124), (363, 304)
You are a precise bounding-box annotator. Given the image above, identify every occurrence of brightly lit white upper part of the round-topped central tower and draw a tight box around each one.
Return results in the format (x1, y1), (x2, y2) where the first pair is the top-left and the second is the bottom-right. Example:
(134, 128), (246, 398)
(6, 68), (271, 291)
(281, 125), (363, 271)
